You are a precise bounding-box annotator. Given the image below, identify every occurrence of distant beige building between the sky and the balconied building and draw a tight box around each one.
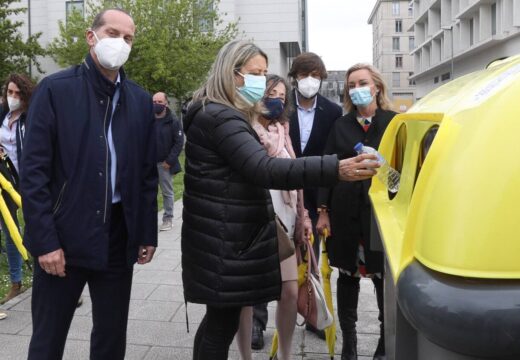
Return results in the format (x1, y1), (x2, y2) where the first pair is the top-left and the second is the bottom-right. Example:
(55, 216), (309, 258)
(368, 0), (416, 112)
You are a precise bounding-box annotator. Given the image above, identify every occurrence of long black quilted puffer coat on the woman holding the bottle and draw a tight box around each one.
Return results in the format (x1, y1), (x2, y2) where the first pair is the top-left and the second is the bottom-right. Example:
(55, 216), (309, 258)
(182, 103), (338, 307)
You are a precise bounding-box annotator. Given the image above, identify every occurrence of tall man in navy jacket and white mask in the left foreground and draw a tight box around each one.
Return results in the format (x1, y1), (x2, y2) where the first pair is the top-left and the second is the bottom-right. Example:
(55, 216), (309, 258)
(21, 9), (157, 359)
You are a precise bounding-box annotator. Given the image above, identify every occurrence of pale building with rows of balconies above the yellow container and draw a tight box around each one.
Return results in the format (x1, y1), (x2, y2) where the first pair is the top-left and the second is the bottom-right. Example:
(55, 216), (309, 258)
(410, 0), (520, 98)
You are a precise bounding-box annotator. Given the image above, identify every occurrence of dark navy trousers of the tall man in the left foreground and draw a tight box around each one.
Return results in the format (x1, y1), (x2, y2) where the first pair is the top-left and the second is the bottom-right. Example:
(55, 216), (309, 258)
(28, 205), (133, 360)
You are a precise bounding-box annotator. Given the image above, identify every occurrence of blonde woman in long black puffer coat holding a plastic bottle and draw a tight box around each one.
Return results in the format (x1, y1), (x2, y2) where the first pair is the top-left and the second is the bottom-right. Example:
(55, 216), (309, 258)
(182, 41), (376, 360)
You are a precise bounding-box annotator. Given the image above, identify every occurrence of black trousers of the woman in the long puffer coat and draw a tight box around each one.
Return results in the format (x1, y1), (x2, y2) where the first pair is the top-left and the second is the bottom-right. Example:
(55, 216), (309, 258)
(193, 305), (242, 360)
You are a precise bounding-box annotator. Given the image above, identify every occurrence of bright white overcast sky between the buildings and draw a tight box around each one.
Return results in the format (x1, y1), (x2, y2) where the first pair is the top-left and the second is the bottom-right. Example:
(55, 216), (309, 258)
(307, 0), (376, 70)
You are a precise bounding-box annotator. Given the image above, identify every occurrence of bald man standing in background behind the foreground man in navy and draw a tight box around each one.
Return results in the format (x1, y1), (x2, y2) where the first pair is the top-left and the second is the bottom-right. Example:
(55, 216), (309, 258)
(153, 92), (184, 231)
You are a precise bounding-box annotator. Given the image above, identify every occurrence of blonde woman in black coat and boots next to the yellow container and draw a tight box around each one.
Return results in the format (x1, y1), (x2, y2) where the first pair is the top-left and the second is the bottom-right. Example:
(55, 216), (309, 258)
(317, 64), (396, 360)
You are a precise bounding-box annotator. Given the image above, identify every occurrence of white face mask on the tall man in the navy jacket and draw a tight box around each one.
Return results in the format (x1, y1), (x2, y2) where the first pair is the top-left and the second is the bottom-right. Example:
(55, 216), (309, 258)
(93, 32), (132, 70)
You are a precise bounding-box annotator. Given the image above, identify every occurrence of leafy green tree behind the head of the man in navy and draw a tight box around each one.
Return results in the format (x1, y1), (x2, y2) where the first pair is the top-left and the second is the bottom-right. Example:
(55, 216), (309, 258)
(49, 0), (238, 100)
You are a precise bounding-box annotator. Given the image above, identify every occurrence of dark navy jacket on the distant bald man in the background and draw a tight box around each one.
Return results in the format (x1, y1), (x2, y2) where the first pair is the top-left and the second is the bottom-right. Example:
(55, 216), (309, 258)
(155, 108), (184, 174)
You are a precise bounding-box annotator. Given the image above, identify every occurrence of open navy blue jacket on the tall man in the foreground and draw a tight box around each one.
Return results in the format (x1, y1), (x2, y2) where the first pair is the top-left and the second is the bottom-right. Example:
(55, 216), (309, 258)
(21, 55), (157, 269)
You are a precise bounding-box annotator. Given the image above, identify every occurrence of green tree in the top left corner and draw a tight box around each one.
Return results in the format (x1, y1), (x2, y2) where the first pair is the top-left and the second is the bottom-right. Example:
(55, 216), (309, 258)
(0, 0), (46, 81)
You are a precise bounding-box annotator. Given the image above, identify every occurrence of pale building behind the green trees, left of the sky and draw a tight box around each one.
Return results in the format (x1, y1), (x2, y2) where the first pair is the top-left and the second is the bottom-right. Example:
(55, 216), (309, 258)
(13, 0), (308, 75)
